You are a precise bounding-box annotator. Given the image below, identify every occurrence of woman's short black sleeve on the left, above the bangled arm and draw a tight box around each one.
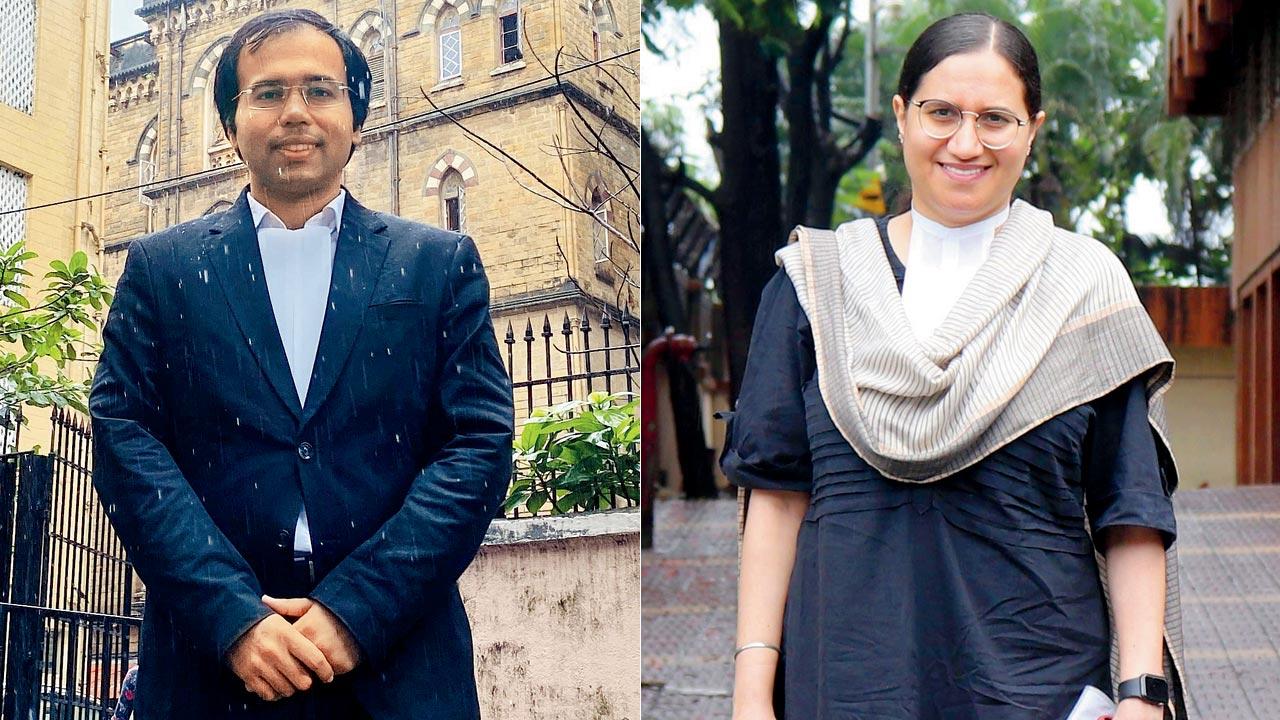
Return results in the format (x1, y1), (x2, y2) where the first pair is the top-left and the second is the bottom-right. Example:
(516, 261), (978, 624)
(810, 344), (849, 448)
(721, 269), (813, 492)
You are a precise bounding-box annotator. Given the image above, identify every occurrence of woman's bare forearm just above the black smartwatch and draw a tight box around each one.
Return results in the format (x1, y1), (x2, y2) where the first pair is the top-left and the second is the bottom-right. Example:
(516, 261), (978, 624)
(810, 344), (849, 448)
(1105, 525), (1165, 682)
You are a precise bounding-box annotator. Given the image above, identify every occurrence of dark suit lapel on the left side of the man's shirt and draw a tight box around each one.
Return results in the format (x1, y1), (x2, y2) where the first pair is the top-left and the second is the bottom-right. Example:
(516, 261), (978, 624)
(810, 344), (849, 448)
(206, 190), (304, 418)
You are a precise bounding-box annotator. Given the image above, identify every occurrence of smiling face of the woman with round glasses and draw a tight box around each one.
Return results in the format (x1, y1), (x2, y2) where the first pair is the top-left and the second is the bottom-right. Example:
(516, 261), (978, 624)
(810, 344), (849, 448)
(893, 50), (1044, 227)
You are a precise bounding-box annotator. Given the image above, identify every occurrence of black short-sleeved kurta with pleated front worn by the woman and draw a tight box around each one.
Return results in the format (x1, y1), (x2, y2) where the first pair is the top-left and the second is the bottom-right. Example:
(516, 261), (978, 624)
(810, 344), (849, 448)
(722, 217), (1175, 720)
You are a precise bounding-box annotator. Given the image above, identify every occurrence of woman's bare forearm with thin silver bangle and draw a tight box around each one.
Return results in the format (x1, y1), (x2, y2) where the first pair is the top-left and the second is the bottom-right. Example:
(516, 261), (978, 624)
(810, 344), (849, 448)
(733, 489), (809, 708)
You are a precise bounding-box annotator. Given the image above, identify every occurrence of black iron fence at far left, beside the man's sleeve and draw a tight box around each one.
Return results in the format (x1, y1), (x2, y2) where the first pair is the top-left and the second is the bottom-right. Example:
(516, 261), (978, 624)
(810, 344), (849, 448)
(0, 443), (141, 720)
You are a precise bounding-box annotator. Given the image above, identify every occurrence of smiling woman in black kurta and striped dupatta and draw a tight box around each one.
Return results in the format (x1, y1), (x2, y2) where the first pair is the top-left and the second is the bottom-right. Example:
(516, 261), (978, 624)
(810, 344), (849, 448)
(723, 14), (1181, 720)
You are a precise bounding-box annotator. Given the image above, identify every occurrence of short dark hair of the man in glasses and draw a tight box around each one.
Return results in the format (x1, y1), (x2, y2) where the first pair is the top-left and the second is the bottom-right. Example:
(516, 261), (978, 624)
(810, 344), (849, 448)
(214, 9), (372, 152)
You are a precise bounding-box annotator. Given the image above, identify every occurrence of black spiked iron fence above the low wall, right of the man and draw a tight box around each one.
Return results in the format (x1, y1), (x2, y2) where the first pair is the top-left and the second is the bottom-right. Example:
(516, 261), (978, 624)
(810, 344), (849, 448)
(503, 311), (640, 518)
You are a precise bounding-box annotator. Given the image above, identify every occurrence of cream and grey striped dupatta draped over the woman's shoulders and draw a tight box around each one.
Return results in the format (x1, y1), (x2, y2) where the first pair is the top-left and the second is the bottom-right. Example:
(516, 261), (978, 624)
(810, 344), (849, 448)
(757, 201), (1185, 720)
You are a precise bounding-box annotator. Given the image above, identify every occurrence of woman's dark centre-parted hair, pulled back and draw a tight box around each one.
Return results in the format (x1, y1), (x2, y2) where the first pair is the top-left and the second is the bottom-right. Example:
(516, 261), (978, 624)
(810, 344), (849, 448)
(897, 13), (1041, 118)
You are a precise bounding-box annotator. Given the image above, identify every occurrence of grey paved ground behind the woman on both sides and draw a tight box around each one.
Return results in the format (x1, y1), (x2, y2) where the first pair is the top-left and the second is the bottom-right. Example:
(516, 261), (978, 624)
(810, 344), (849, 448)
(641, 486), (1280, 720)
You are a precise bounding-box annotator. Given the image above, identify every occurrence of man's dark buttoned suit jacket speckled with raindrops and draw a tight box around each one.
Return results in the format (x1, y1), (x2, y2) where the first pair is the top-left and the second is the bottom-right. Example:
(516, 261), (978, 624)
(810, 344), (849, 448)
(90, 188), (512, 720)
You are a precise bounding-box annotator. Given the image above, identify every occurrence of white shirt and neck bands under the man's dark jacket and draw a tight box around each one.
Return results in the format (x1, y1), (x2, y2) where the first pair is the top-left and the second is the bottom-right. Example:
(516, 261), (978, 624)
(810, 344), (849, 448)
(248, 190), (347, 552)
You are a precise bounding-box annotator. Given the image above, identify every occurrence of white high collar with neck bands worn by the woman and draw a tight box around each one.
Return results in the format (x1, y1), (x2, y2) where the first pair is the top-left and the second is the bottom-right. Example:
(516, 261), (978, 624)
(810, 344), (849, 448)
(902, 208), (1009, 341)
